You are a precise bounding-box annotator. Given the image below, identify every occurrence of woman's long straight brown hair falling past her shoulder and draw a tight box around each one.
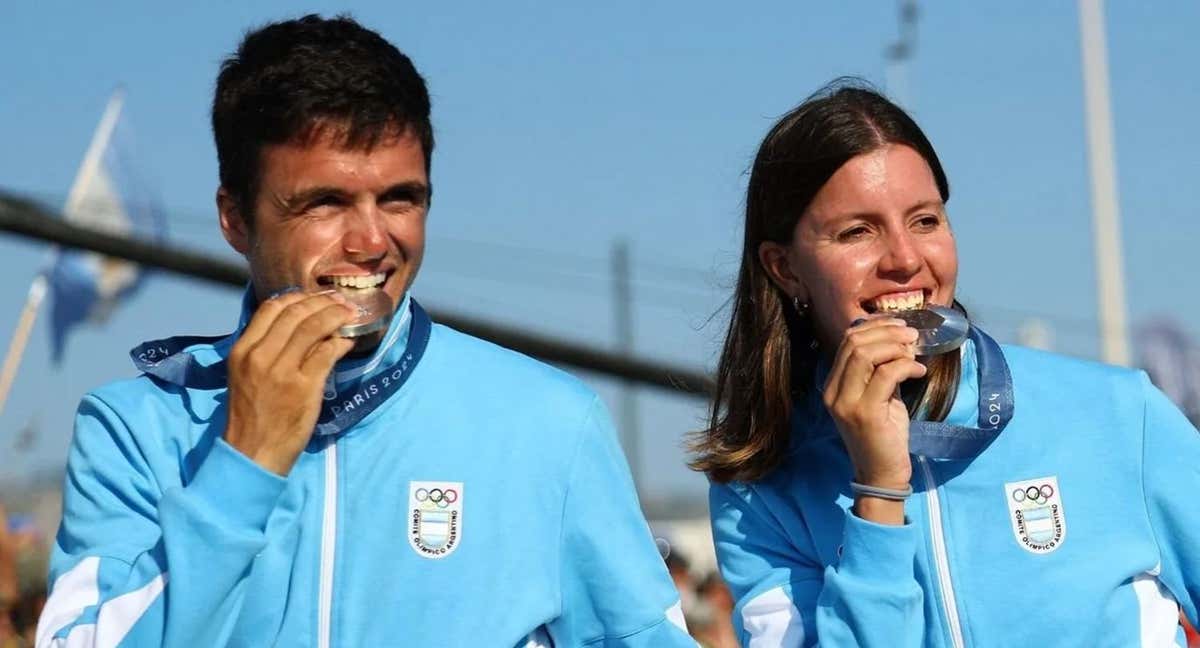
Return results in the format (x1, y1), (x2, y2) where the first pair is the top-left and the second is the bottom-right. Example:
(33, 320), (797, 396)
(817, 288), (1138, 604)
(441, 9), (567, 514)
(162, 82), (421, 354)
(690, 79), (961, 482)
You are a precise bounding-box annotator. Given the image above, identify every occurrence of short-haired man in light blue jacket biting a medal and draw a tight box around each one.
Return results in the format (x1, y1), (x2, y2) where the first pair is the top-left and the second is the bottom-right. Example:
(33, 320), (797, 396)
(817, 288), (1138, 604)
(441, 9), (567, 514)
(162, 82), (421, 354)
(38, 16), (692, 648)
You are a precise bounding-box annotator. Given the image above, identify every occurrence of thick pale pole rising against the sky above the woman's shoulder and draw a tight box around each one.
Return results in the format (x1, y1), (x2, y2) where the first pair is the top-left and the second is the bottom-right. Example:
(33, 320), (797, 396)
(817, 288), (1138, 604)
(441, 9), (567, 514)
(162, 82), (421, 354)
(1079, 0), (1129, 365)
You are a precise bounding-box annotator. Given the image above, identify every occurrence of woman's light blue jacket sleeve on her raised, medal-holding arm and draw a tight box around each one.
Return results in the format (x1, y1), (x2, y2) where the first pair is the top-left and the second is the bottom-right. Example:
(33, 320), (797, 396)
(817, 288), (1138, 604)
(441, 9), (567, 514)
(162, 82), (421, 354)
(709, 472), (924, 648)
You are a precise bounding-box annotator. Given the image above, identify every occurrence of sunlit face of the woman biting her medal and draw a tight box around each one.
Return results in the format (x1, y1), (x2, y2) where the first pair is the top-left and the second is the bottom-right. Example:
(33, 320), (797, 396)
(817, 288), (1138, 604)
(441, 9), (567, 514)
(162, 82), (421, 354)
(761, 145), (959, 349)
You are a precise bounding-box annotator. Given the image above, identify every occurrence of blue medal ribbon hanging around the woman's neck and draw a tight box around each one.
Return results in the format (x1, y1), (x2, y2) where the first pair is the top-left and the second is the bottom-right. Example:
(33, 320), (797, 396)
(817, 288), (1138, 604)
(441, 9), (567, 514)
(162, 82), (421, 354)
(908, 325), (1014, 460)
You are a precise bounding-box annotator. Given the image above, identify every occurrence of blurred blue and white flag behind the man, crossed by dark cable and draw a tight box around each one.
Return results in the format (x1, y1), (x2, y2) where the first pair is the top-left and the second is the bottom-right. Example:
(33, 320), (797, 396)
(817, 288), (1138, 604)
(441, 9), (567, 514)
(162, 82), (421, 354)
(47, 92), (166, 365)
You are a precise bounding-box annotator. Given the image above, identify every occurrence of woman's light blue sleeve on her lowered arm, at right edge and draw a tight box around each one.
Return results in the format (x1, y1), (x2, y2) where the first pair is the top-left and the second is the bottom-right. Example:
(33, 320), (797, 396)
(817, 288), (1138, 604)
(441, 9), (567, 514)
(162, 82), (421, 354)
(1141, 373), (1200, 625)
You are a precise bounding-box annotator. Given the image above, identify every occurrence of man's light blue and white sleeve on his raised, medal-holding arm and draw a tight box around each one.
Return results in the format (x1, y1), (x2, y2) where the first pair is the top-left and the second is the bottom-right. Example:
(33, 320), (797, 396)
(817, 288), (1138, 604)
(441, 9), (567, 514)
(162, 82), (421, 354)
(36, 395), (286, 648)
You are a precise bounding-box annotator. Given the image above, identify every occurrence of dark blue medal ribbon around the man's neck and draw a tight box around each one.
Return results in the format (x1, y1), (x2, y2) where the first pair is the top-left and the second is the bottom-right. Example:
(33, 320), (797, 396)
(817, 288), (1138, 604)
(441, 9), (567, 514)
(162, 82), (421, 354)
(130, 300), (433, 436)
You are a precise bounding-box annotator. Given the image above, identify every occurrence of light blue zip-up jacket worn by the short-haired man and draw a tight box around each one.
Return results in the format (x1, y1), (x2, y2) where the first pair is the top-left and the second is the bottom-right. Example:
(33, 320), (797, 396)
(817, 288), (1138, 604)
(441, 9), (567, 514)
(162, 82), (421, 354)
(37, 295), (695, 648)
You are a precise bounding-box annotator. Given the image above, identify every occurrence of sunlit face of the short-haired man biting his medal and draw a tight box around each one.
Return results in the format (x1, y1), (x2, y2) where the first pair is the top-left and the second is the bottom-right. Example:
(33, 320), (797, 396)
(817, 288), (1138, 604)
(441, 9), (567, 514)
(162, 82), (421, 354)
(218, 126), (430, 326)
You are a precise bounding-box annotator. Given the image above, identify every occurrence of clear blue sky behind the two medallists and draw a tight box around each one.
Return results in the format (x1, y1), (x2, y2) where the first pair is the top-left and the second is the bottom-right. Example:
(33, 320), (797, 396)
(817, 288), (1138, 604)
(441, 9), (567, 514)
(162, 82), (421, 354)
(0, 0), (1200, 504)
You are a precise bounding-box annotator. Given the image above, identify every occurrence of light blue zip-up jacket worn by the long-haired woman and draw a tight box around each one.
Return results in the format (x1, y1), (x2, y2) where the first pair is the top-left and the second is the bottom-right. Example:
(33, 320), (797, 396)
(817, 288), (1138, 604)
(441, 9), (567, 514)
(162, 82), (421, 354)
(710, 336), (1200, 648)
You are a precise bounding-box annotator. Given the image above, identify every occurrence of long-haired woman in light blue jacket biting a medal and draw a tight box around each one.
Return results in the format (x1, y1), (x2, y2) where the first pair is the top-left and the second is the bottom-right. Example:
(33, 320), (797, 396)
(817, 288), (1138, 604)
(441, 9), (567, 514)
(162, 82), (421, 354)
(694, 84), (1200, 647)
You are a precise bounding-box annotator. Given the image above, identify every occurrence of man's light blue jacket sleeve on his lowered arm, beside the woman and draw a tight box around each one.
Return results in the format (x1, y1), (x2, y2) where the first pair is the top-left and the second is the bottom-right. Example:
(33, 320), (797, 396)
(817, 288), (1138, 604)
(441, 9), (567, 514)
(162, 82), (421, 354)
(550, 398), (696, 648)
